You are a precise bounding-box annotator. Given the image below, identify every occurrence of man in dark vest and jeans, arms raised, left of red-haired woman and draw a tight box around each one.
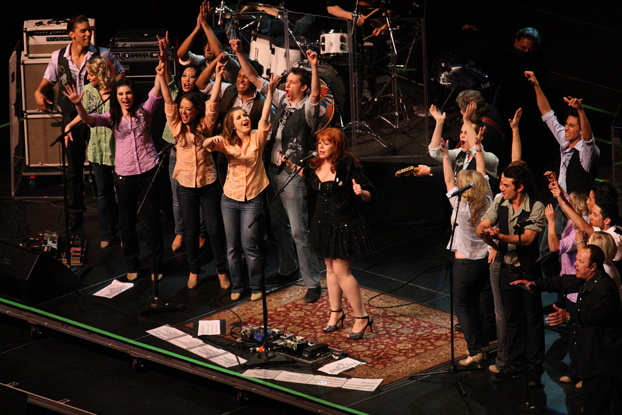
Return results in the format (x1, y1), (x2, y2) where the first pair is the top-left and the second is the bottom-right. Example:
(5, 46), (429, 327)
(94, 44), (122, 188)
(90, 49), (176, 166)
(231, 41), (322, 303)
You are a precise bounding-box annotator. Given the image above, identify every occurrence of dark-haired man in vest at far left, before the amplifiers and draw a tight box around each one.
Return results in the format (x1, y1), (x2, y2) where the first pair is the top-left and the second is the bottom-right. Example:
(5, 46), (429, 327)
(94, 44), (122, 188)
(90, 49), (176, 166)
(35, 15), (125, 230)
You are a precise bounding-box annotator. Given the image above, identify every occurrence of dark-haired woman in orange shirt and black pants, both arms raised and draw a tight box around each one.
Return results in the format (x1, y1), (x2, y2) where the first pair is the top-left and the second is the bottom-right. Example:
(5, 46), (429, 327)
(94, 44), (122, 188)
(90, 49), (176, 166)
(156, 57), (231, 289)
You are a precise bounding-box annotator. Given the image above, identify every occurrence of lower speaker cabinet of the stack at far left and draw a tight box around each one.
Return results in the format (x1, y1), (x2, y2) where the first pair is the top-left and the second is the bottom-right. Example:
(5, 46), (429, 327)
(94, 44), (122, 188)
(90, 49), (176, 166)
(24, 114), (62, 167)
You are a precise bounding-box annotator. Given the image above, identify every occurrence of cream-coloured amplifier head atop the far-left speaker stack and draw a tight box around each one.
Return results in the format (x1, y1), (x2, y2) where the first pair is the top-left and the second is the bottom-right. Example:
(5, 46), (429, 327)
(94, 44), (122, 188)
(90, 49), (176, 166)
(24, 19), (96, 58)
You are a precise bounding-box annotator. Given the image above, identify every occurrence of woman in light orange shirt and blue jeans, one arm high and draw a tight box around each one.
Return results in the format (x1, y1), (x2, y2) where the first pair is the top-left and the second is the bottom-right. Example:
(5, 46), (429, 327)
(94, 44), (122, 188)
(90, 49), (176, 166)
(203, 76), (280, 301)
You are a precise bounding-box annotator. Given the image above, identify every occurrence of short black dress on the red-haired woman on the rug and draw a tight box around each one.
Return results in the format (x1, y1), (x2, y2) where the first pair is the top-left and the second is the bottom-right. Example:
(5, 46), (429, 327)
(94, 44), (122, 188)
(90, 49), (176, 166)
(304, 155), (375, 259)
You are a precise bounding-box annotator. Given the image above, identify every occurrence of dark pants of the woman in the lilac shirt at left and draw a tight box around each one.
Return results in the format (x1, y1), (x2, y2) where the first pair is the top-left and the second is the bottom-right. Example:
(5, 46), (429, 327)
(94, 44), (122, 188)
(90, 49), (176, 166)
(114, 167), (164, 275)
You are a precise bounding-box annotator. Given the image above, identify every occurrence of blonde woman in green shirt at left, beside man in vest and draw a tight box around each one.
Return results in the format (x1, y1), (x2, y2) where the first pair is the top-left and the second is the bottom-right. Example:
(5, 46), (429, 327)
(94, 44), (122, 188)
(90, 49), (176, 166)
(65, 56), (119, 248)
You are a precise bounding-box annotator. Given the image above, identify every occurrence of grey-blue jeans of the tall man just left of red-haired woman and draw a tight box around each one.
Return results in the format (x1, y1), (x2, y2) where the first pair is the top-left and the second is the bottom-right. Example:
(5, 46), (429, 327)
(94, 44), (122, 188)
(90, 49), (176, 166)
(267, 164), (320, 288)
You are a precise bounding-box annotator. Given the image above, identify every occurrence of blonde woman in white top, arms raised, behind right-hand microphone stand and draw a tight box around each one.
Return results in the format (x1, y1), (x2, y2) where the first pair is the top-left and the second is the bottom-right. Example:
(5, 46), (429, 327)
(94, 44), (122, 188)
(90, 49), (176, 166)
(440, 122), (492, 367)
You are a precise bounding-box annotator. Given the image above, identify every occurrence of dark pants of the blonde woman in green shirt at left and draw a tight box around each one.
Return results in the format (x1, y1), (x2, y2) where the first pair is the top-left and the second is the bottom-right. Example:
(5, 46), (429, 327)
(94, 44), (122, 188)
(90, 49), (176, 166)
(91, 163), (119, 242)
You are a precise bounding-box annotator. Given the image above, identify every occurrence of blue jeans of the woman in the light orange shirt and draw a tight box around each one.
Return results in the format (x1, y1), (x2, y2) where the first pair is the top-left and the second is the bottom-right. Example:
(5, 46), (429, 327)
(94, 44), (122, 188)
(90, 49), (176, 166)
(220, 194), (264, 294)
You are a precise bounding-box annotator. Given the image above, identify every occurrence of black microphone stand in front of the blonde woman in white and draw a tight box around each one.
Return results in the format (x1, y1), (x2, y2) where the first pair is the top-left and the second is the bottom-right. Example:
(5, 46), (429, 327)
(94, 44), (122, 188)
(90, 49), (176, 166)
(408, 189), (481, 413)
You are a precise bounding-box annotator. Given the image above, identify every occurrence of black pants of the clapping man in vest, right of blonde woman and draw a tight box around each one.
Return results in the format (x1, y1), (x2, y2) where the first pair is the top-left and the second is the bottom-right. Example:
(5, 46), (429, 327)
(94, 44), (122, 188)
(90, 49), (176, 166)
(499, 266), (544, 374)
